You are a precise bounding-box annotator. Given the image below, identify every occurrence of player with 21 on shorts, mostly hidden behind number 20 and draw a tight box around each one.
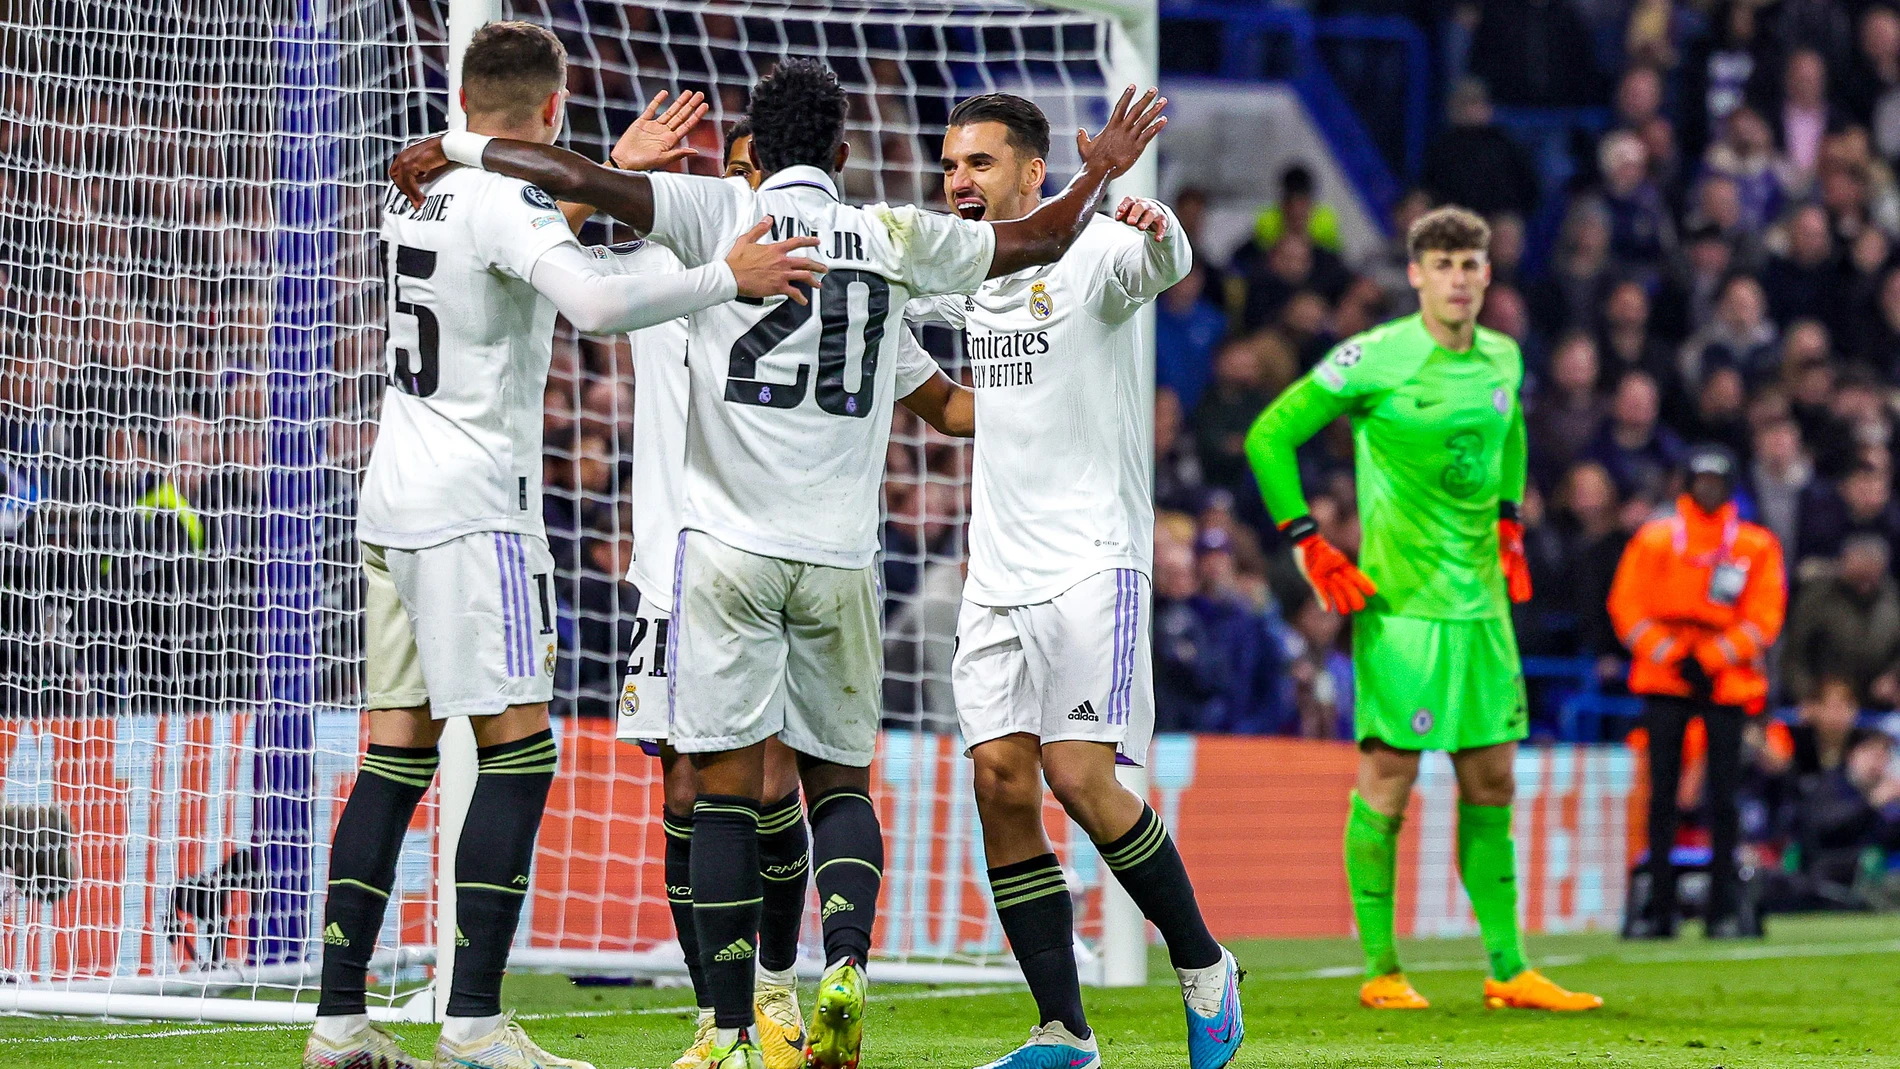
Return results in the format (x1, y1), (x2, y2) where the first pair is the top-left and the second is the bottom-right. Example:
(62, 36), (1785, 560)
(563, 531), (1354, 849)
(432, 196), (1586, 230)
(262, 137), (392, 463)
(589, 114), (975, 1069)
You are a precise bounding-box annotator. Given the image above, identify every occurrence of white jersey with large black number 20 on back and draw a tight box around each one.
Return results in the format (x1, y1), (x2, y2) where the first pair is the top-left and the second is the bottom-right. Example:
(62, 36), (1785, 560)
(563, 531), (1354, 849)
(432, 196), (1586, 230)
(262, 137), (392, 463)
(652, 167), (996, 568)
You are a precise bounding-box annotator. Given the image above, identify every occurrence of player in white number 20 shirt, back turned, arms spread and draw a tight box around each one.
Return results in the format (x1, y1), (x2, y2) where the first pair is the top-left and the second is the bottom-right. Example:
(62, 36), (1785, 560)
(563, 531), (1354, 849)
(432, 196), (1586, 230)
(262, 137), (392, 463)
(393, 59), (1163, 1069)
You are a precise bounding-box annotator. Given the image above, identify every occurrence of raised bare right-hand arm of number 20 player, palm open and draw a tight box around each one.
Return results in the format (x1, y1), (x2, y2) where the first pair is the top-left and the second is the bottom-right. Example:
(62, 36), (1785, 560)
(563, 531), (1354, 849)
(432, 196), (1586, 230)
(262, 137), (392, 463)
(990, 85), (1169, 279)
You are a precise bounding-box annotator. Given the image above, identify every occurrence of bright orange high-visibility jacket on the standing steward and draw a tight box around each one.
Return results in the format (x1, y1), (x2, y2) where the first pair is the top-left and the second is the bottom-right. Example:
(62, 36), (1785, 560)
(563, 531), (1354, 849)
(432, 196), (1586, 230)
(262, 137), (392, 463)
(1609, 494), (1788, 712)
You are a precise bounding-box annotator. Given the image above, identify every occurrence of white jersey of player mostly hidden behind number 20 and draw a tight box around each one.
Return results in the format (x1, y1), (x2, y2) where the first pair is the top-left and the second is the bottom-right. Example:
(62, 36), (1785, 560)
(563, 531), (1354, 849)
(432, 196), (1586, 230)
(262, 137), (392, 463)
(587, 241), (688, 613)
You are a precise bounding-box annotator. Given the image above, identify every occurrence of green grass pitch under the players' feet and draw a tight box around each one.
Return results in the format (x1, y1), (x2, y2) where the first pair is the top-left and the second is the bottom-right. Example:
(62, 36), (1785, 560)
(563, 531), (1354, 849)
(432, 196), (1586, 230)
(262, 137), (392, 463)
(0, 917), (1900, 1069)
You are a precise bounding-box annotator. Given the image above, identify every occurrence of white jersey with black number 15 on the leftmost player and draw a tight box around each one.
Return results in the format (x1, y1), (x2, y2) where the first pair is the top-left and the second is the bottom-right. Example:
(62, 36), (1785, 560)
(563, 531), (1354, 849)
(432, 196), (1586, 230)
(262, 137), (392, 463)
(357, 167), (574, 549)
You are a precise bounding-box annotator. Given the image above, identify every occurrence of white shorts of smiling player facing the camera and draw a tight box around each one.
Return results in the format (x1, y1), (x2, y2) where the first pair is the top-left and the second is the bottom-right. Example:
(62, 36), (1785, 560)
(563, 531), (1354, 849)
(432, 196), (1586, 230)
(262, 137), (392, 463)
(950, 568), (1155, 765)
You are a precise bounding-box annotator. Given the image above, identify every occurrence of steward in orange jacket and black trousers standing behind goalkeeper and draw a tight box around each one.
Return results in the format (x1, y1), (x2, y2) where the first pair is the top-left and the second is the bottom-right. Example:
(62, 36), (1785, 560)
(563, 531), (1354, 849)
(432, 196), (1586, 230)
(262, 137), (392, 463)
(1609, 446), (1788, 940)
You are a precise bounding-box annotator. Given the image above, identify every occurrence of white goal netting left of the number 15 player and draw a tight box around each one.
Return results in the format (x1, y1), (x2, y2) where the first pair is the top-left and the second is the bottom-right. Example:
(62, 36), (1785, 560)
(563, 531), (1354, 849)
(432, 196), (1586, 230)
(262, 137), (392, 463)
(0, 0), (428, 991)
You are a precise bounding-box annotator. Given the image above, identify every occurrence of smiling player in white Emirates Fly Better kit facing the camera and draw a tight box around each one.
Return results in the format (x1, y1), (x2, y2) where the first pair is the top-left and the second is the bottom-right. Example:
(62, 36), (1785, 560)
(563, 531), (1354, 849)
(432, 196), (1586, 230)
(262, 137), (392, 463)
(906, 93), (1243, 1069)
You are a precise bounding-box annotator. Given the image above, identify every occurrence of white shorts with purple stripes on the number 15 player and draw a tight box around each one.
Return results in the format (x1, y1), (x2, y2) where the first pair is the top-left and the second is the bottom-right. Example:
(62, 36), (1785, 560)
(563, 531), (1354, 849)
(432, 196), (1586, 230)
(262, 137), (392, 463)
(363, 532), (557, 720)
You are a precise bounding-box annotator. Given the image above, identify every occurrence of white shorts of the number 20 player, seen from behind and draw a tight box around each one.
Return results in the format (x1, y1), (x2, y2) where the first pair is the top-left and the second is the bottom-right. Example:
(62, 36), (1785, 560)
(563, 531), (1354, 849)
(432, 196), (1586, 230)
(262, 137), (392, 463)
(667, 530), (884, 767)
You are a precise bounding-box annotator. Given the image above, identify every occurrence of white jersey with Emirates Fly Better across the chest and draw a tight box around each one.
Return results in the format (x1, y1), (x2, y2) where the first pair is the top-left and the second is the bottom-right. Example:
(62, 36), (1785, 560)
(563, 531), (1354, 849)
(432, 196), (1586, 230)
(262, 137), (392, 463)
(906, 215), (1193, 606)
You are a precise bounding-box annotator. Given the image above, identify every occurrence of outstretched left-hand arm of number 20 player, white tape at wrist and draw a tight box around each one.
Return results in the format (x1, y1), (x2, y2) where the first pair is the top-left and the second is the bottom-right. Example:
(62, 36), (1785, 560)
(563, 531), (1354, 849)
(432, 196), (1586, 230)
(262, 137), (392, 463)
(390, 135), (654, 234)
